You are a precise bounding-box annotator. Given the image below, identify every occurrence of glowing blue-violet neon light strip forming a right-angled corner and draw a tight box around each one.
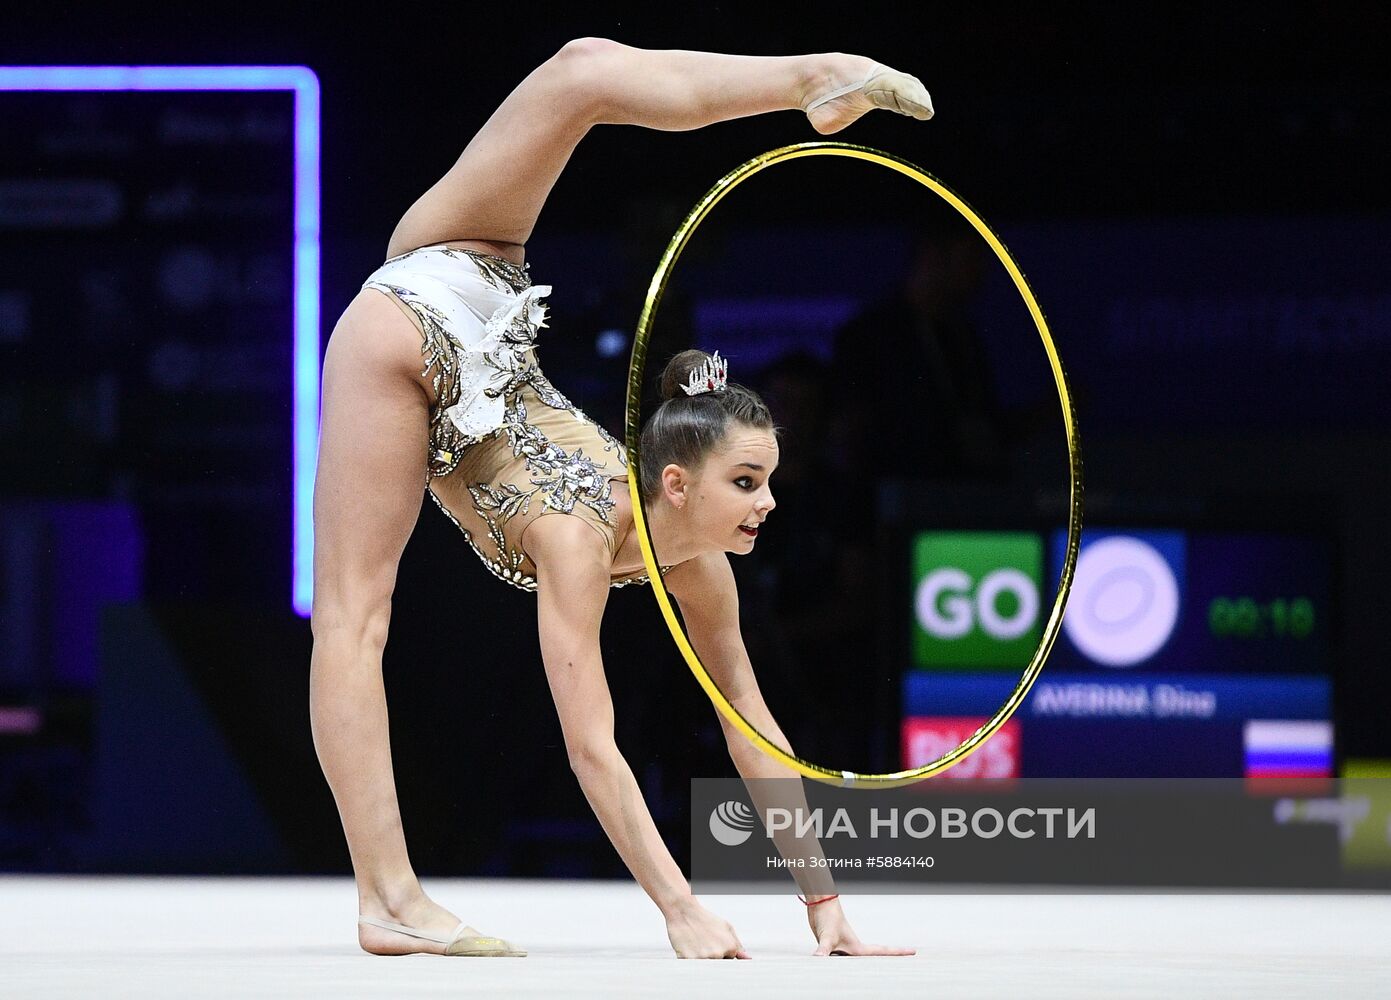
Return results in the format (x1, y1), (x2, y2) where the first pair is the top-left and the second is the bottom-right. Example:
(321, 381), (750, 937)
(0, 65), (320, 616)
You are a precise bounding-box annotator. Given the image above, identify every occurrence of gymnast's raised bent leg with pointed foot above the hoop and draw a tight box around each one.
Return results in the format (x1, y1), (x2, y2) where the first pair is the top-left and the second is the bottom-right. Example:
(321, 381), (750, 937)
(388, 38), (932, 261)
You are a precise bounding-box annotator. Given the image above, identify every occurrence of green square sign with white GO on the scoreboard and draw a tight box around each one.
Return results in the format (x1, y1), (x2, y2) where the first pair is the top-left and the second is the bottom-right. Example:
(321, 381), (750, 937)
(912, 531), (1043, 670)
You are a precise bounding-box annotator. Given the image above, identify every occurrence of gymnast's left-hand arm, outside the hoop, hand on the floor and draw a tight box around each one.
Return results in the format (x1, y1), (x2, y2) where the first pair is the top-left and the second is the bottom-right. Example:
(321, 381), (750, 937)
(523, 515), (748, 958)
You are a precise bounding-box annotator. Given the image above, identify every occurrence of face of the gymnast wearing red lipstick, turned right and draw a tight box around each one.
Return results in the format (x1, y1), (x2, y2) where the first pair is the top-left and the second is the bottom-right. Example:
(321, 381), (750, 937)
(686, 424), (778, 555)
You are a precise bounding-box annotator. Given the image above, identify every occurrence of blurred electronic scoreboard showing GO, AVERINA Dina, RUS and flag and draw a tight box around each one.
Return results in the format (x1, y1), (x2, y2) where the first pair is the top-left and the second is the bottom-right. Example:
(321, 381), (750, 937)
(899, 524), (1334, 780)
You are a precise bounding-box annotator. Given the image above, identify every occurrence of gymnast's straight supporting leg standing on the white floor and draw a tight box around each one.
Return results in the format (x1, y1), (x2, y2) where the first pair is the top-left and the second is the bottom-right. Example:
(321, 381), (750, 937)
(310, 291), (467, 954)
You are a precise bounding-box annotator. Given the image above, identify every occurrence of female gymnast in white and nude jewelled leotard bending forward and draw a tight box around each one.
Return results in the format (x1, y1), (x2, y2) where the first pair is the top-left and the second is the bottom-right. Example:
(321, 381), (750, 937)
(310, 38), (932, 958)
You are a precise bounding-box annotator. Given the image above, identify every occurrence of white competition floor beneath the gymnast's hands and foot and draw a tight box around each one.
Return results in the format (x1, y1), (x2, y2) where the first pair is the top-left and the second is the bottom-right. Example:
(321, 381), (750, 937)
(0, 876), (1391, 1000)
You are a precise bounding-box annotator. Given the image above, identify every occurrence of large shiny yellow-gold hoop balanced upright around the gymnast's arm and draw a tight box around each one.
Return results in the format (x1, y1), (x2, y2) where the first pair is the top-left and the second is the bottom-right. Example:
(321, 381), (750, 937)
(625, 142), (1082, 789)
